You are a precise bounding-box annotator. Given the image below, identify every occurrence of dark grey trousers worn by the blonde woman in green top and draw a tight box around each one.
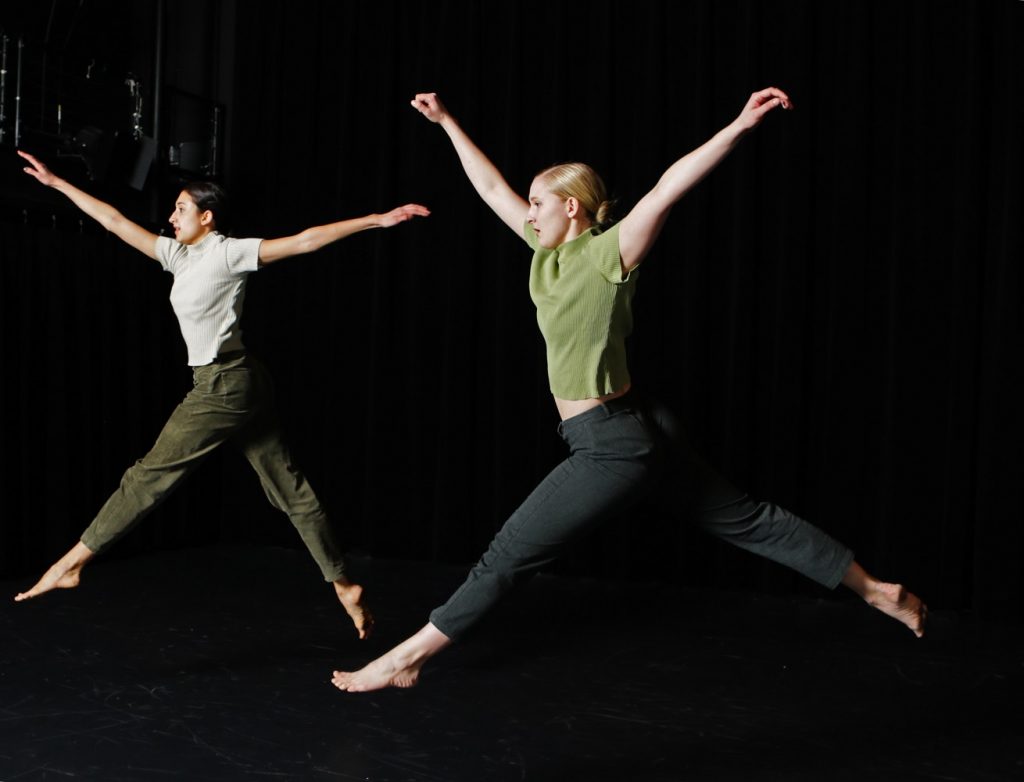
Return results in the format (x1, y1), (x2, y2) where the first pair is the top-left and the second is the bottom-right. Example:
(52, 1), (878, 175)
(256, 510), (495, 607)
(430, 392), (853, 639)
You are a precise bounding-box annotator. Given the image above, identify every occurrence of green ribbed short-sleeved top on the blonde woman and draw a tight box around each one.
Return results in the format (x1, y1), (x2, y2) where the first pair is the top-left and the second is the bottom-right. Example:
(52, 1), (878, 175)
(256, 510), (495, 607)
(523, 223), (638, 399)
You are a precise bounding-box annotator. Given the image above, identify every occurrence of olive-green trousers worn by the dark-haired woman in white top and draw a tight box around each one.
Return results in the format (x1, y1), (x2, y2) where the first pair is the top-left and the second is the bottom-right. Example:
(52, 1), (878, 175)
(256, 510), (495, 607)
(82, 354), (345, 581)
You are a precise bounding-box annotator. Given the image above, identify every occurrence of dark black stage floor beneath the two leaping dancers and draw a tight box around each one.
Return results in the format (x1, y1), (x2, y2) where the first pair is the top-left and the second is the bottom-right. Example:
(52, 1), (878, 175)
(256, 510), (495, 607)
(0, 548), (1024, 782)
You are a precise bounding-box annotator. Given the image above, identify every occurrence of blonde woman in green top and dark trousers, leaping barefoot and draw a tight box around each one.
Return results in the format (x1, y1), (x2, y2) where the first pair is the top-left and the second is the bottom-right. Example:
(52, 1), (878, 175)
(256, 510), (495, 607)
(333, 88), (927, 692)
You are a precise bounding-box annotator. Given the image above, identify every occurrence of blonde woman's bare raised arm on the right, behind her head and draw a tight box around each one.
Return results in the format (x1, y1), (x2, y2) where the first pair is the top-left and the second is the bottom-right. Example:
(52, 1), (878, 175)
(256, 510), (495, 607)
(618, 87), (793, 271)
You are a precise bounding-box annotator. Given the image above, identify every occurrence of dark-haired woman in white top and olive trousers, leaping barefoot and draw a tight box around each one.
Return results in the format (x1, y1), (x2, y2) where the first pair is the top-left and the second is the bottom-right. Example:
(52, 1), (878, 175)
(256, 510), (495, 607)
(14, 151), (429, 638)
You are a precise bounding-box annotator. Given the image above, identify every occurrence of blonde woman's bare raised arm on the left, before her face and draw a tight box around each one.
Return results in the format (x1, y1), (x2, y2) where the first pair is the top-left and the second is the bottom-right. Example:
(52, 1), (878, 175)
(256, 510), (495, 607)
(412, 92), (529, 236)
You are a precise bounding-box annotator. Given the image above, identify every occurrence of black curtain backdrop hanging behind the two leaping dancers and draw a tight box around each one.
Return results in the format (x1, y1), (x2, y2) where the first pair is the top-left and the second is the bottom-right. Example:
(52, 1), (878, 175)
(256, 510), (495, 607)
(0, 0), (1024, 621)
